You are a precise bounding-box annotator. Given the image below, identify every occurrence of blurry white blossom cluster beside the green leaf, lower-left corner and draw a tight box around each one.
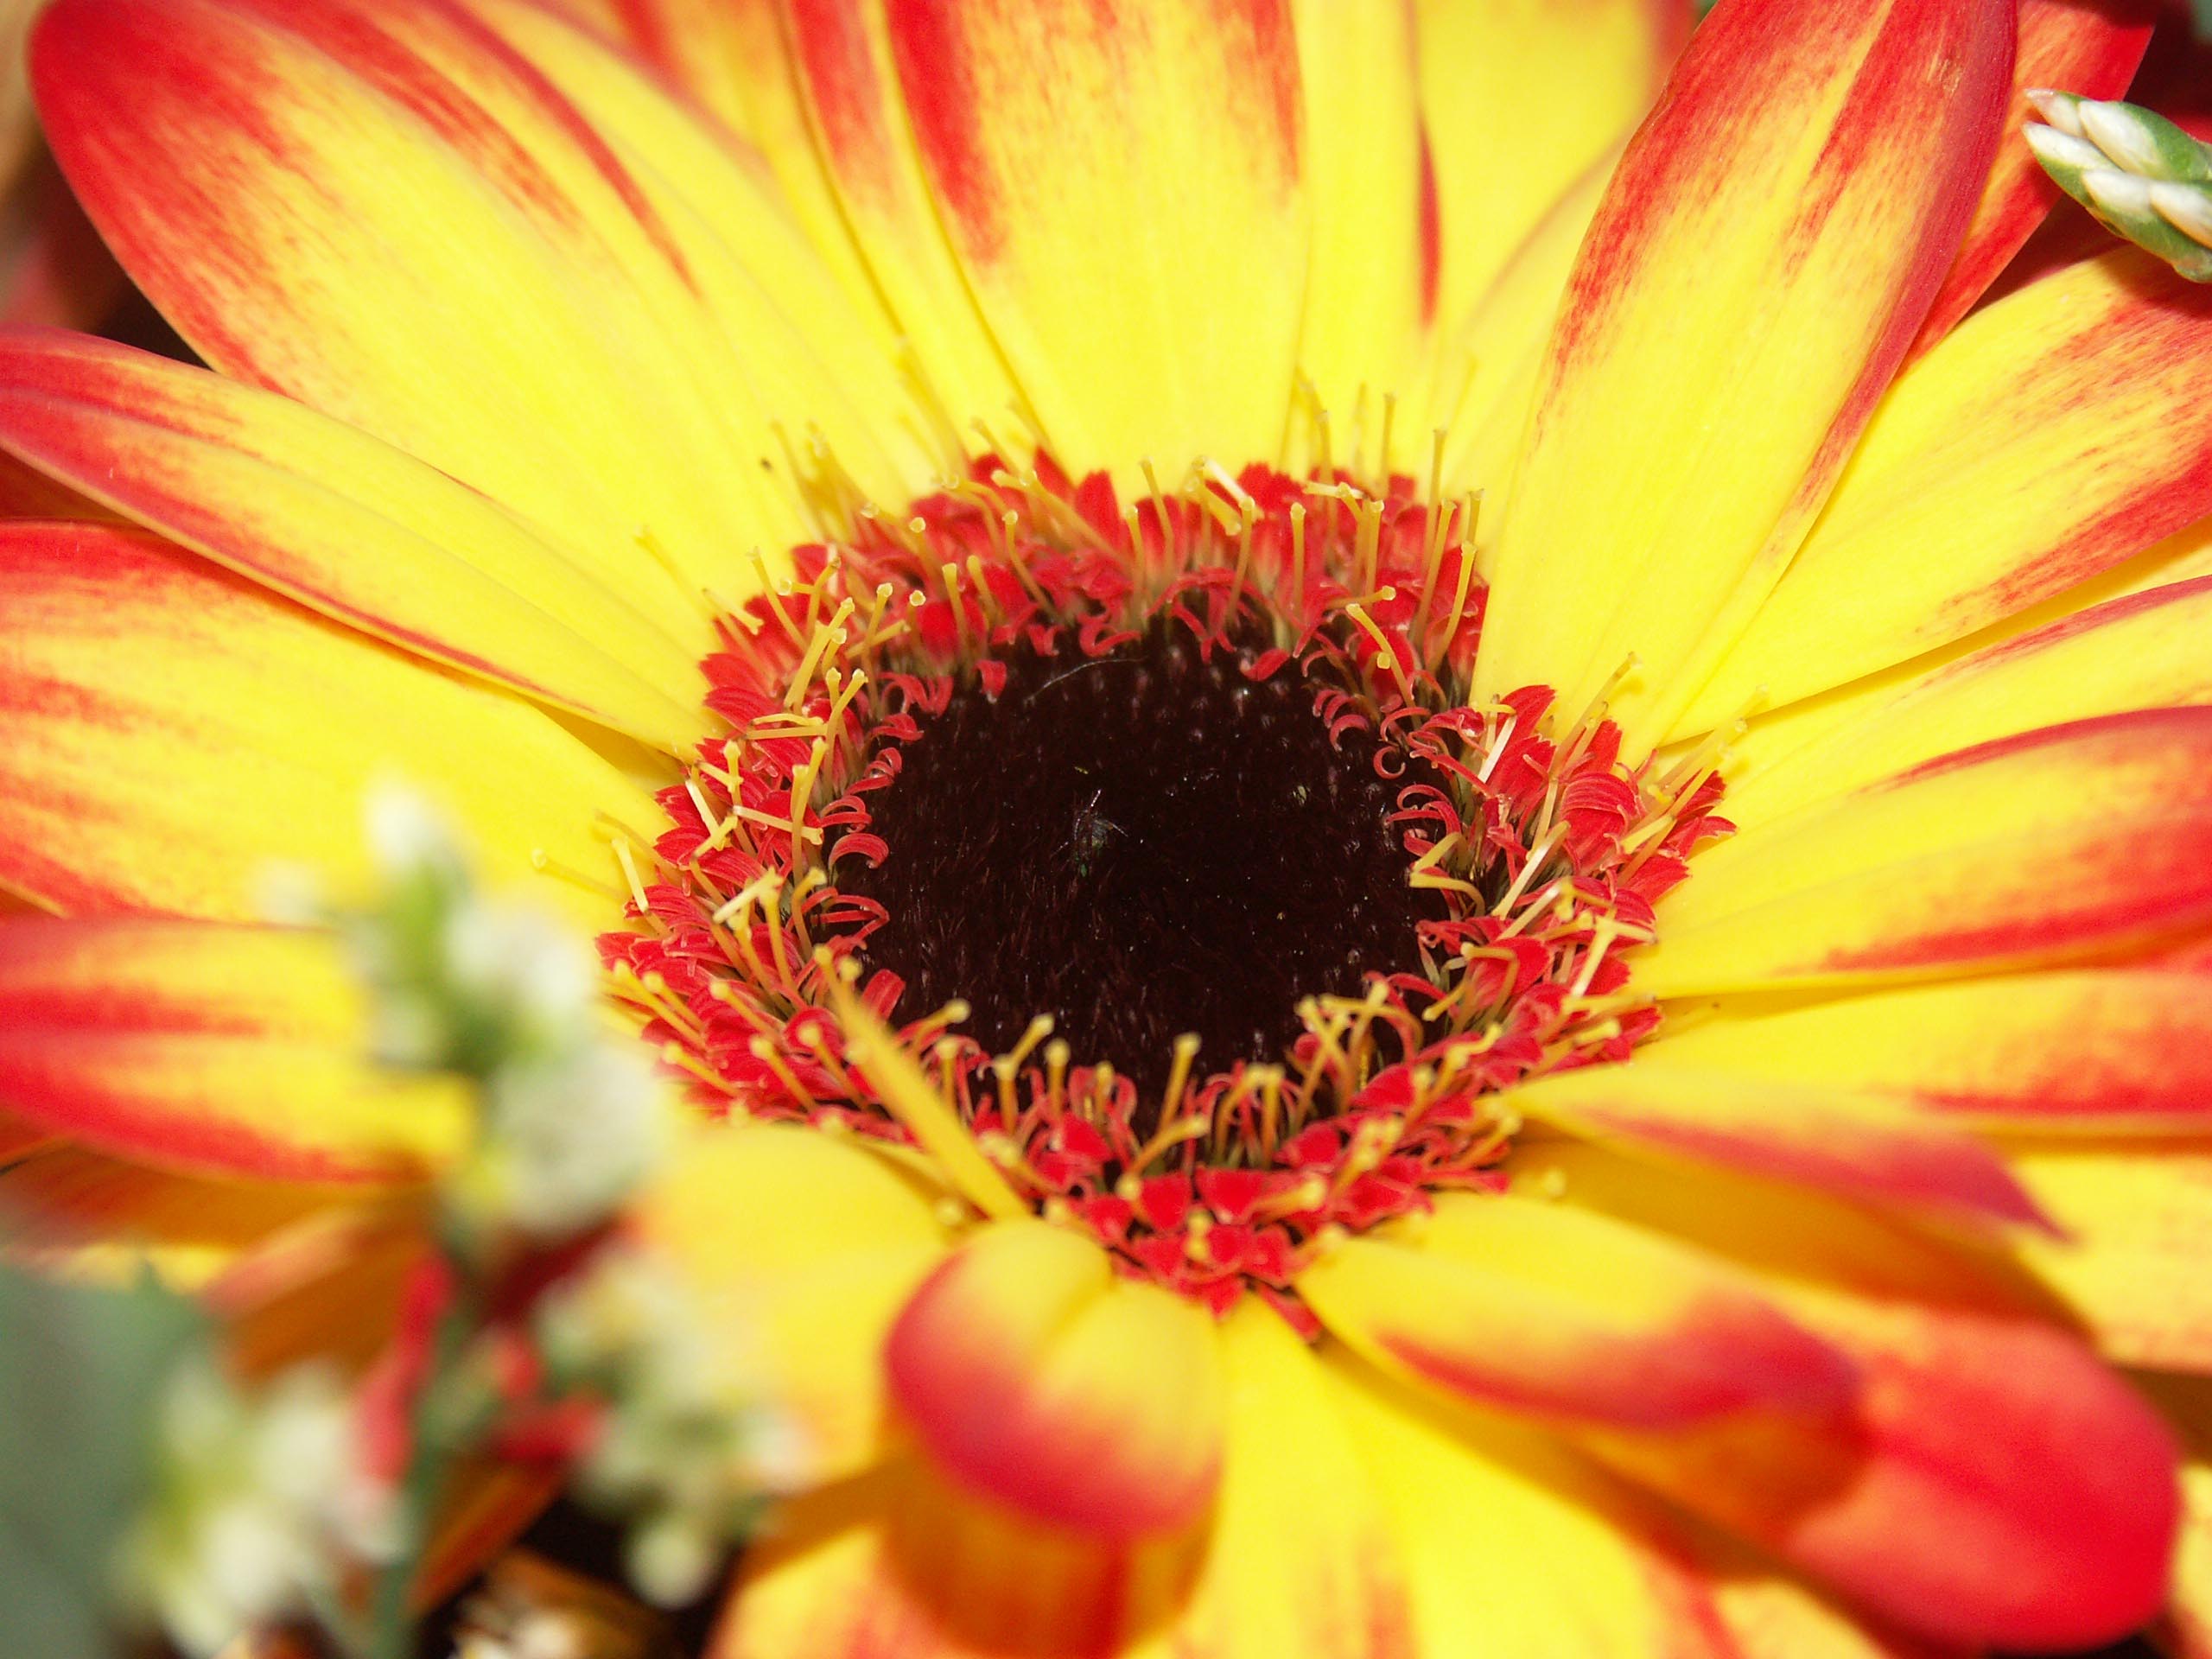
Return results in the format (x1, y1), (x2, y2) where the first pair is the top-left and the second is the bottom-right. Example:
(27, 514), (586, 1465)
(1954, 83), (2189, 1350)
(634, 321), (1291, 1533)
(122, 1356), (391, 1655)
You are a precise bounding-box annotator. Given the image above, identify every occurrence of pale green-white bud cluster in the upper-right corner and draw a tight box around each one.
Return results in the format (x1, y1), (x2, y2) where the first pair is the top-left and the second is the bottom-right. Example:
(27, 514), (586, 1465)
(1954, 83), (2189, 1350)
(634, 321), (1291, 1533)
(2029, 91), (2212, 283)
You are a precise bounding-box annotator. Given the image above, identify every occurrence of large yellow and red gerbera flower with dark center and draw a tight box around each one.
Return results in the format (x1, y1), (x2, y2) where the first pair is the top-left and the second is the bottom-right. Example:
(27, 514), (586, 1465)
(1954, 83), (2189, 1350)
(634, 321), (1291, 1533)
(0, 0), (2212, 1659)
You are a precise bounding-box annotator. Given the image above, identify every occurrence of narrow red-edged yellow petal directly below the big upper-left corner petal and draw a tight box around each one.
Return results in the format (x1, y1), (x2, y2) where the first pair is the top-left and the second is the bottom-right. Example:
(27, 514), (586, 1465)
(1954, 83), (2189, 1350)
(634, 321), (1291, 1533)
(0, 329), (710, 747)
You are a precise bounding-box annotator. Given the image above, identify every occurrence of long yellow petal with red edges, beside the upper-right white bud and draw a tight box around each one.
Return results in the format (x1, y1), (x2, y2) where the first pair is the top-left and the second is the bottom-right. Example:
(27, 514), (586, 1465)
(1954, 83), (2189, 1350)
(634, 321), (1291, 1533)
(1476, 0), (2013, 752)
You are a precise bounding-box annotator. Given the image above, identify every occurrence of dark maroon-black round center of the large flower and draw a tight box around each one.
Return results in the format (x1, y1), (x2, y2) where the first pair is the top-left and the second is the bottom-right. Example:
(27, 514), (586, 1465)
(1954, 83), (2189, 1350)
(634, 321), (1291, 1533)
(841, 621), (1442, 1133)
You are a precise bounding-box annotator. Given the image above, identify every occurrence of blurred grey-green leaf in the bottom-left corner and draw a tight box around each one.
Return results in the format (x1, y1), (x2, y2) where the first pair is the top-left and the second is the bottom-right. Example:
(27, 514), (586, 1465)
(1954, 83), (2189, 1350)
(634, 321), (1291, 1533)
(0, 1269), (201, 1659)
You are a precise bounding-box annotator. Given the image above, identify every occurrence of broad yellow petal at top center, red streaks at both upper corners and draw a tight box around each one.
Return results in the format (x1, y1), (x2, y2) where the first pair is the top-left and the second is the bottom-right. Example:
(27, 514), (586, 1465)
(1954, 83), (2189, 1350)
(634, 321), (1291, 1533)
(885, 0), (1307, 480)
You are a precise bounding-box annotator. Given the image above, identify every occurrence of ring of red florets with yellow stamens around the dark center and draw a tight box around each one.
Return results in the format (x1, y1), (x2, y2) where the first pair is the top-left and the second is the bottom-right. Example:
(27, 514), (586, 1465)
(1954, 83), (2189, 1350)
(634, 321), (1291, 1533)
(601, 455), (1726, 1327)
